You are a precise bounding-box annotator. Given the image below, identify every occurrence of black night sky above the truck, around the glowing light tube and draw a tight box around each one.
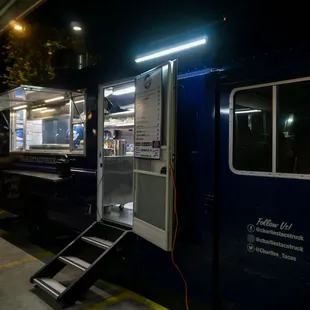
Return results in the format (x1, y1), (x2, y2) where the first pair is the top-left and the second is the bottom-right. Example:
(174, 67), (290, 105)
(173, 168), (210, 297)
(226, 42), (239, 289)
(0, 0), (310, 88)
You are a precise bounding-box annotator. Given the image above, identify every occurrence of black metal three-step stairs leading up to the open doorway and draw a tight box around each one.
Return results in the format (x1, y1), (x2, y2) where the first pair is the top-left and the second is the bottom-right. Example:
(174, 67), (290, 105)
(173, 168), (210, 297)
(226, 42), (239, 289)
(30, 222), (134, 306)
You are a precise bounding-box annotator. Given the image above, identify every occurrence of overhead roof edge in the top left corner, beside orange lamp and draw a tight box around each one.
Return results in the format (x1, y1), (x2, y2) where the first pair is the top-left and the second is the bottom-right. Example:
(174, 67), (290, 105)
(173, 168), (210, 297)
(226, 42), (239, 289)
(0, 0), (45, 34)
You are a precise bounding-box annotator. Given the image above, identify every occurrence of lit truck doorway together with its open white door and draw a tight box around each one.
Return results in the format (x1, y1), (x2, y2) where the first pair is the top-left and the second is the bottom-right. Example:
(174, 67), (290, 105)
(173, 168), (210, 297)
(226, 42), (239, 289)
(97, 61), (177, 254)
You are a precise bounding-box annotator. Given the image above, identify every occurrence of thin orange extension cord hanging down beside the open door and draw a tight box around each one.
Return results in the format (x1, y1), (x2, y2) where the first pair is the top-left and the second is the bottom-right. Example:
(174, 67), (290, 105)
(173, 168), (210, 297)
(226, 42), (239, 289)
(170, 164), (189, 310)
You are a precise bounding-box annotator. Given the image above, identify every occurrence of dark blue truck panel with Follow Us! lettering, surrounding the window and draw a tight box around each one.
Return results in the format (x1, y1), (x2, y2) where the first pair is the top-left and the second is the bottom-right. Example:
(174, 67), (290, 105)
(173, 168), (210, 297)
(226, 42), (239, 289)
(220, 70), (310, 310)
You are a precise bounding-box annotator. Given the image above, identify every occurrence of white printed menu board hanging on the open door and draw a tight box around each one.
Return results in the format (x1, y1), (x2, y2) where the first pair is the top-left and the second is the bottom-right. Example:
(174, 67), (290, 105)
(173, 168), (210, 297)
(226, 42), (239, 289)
(135, 68), (162, 159)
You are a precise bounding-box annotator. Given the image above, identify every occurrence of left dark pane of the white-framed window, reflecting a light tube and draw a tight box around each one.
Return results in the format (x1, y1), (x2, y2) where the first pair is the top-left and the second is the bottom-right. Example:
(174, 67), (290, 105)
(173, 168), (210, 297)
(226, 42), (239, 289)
(233, 87), (272, 172)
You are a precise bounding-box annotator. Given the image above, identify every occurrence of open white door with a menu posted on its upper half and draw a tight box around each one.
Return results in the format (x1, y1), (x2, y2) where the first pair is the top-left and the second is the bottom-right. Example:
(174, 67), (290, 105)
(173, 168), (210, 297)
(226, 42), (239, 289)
(133, 60), (177, 251)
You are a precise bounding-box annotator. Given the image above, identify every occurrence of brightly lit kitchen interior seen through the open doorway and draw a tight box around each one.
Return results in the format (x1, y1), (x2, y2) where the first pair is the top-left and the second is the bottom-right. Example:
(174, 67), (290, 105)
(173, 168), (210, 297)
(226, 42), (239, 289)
(103, 81), (135, 226)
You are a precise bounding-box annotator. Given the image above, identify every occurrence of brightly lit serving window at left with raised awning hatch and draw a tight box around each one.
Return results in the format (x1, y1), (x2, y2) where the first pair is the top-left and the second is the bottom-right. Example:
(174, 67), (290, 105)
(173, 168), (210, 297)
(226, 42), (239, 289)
(0, 86), (86, 155)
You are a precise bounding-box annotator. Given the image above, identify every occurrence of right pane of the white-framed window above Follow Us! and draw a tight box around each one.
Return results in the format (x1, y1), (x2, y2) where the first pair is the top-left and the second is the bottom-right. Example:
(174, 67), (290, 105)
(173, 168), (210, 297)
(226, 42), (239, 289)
(276, 81), (310, 174)
